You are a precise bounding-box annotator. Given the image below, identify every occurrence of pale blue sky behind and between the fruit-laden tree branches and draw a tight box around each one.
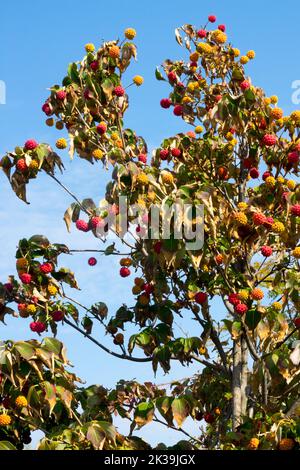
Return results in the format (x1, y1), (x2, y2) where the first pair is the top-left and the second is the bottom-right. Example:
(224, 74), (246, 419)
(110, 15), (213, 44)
(0, 0), (300, 443)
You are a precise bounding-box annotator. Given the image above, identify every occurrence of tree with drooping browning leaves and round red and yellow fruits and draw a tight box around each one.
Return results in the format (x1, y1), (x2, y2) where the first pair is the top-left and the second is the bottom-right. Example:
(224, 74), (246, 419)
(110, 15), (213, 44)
(0, 16), (300, 450)
